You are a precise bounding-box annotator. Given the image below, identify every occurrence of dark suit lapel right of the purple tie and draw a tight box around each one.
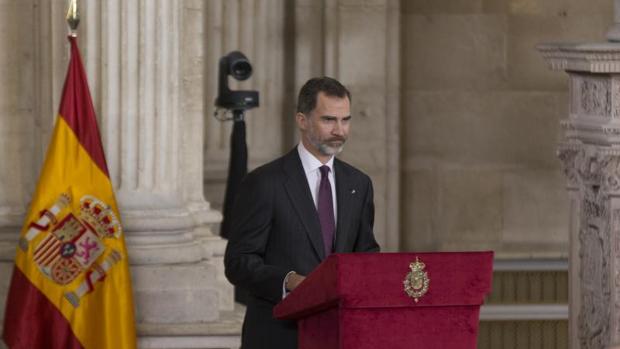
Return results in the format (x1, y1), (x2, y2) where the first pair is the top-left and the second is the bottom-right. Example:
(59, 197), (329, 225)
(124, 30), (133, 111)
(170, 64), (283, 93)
(334, 159), (355, 252)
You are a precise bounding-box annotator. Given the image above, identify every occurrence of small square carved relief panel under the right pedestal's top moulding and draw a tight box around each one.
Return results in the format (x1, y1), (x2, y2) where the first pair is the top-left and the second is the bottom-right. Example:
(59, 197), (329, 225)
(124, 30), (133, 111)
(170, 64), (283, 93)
(579, 77), (611, 118)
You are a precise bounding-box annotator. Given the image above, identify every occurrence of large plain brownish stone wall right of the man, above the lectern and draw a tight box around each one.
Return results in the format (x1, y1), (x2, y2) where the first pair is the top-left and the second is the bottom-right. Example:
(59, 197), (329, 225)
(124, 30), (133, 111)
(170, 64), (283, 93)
(401, 0), (613, 258)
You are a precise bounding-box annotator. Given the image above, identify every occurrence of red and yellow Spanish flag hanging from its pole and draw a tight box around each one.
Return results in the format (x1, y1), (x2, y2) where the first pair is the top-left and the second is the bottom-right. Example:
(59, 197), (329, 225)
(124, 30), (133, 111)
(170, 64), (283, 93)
(3, 36), (136, 349)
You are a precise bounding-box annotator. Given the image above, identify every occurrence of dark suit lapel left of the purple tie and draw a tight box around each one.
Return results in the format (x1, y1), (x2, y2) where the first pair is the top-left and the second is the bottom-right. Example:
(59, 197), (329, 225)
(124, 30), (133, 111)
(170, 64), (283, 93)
(284, 148), (325, 260)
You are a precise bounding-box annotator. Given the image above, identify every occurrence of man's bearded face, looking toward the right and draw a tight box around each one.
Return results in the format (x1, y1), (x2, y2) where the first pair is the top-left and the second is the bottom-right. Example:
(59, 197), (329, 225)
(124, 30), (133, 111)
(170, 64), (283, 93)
(297, 92), (351, 157)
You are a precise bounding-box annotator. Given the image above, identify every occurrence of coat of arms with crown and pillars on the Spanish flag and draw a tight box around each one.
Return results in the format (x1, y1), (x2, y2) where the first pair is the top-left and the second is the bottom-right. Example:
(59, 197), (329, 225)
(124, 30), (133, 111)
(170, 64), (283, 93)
(19, 193), (122, 307)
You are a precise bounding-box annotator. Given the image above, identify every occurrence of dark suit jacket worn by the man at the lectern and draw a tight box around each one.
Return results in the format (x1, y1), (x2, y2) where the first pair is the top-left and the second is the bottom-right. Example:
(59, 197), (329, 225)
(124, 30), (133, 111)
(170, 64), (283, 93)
(224, 148), (379, 349)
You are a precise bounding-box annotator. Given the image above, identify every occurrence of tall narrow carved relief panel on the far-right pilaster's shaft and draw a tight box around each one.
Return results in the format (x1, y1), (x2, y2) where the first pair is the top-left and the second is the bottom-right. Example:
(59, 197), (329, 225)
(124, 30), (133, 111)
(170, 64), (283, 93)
(578, 185), (611, 349)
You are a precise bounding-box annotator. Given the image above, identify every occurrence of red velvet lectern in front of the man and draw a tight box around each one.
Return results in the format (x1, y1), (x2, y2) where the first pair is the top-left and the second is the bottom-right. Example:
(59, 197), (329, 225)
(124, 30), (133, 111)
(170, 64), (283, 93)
(274, 252), (493, 349)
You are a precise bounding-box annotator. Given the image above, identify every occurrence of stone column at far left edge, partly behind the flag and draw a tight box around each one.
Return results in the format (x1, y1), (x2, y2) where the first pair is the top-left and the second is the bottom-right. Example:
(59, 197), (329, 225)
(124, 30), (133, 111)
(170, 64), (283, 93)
(0, 0), (37, 324)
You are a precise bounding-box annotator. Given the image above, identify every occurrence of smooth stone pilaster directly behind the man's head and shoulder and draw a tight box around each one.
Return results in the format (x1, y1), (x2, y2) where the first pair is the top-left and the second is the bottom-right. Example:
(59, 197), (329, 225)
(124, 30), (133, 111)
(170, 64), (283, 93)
(291, 0), (400, 251)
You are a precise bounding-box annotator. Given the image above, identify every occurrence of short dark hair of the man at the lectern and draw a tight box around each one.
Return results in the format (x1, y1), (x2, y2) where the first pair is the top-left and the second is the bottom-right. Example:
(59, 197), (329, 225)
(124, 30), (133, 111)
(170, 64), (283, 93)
(297, 76), (351, 115)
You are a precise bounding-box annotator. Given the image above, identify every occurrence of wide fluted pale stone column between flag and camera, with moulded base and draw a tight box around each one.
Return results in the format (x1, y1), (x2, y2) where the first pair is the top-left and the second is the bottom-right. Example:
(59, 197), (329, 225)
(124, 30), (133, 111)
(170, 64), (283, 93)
(80, 0), (232, 324)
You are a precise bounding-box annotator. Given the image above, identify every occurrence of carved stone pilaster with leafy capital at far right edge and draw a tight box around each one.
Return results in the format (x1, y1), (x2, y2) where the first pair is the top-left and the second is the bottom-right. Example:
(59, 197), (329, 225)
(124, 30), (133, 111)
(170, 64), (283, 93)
(558, 142), (620, 349)
